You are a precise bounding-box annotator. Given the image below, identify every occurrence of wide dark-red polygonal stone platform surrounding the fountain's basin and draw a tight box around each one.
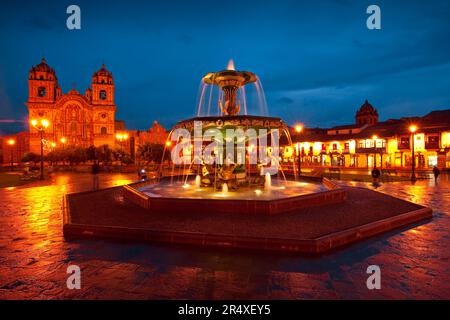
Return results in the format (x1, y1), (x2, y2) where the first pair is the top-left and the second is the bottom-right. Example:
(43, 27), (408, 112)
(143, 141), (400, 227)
(63, 179), (432, 254)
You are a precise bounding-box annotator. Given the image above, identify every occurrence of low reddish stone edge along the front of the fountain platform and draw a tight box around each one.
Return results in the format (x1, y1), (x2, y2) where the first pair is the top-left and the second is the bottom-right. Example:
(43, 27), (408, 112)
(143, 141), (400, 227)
(64, 208), (432, 254)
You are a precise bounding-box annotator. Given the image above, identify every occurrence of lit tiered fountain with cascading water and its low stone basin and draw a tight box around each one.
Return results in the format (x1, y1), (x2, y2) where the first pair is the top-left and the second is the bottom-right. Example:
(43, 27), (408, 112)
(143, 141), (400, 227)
(124, 63), (345, 214)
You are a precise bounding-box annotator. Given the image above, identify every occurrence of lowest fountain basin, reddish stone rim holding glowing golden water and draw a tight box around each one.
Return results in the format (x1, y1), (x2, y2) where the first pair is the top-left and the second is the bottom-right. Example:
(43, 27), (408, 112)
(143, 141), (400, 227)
(124, 179), (346, 215)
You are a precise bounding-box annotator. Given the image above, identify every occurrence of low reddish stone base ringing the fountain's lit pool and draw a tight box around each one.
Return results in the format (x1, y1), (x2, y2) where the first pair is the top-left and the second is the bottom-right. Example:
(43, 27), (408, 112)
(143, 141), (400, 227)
(123, 178), (346, 215)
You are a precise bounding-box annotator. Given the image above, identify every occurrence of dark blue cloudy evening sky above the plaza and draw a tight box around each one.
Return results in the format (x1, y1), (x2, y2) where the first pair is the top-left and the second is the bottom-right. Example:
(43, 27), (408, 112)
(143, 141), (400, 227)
(0, 0), (450, 129)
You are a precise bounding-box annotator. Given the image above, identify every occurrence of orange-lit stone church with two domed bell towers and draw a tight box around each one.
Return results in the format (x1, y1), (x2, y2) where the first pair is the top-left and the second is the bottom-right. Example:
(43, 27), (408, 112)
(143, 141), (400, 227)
(25, 59), (116, 153)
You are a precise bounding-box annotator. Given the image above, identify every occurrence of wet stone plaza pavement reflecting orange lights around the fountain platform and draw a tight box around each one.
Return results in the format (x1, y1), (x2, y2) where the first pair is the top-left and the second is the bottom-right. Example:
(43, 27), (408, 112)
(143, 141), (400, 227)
(0, 174), (450, 299)
